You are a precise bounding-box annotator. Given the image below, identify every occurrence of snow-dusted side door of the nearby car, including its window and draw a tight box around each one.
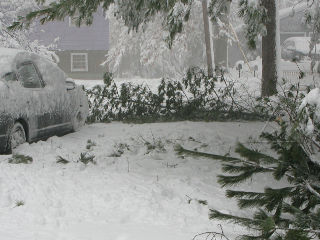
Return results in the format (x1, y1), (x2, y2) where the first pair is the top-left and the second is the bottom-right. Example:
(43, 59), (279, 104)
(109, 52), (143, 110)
(17, 61), (67, 140)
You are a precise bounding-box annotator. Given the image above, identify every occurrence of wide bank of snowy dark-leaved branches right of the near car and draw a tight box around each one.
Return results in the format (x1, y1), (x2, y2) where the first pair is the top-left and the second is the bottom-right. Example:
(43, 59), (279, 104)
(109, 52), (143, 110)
(87, 67), (263, 122)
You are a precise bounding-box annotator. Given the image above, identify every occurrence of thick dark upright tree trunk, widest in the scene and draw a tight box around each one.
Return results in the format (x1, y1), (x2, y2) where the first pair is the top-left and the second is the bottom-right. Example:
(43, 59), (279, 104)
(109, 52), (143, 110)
(261, 0), (278, 96)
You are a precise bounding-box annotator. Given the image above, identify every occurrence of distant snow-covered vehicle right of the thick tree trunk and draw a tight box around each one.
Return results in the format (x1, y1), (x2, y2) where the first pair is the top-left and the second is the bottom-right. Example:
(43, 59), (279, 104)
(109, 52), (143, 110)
(281, 37), (320, 61)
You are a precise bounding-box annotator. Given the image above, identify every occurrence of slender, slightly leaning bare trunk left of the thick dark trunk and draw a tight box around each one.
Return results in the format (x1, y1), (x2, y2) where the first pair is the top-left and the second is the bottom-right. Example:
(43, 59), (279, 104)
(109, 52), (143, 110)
(202, 0), (213, 77)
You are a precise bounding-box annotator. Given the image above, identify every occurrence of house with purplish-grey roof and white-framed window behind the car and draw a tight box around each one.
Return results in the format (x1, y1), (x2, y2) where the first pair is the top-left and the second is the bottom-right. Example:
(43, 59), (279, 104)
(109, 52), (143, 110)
(31, 10), (109, 79)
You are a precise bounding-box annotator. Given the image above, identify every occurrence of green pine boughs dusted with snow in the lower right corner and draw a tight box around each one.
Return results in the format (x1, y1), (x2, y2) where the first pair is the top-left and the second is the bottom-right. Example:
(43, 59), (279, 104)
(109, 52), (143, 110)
(178, 89), (320, 240)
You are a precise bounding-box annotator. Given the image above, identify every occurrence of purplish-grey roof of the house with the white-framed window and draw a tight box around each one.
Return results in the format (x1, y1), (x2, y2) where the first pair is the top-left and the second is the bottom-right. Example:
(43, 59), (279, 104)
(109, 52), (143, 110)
(31, 11), (109, 50)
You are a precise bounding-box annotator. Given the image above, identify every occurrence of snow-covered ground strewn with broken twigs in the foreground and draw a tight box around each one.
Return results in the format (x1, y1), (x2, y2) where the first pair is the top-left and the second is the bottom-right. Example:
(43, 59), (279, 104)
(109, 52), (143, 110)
(0, 122), (280, 240)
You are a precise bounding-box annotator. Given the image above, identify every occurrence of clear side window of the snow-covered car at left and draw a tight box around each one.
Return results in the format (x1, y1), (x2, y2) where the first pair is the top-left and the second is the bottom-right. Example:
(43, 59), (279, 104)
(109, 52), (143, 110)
(18, 62), (44, 88)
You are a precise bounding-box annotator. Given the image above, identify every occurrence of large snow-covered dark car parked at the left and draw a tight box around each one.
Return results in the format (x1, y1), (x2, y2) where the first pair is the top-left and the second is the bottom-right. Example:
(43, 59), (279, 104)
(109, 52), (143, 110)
(0, 48), (88, 153)
